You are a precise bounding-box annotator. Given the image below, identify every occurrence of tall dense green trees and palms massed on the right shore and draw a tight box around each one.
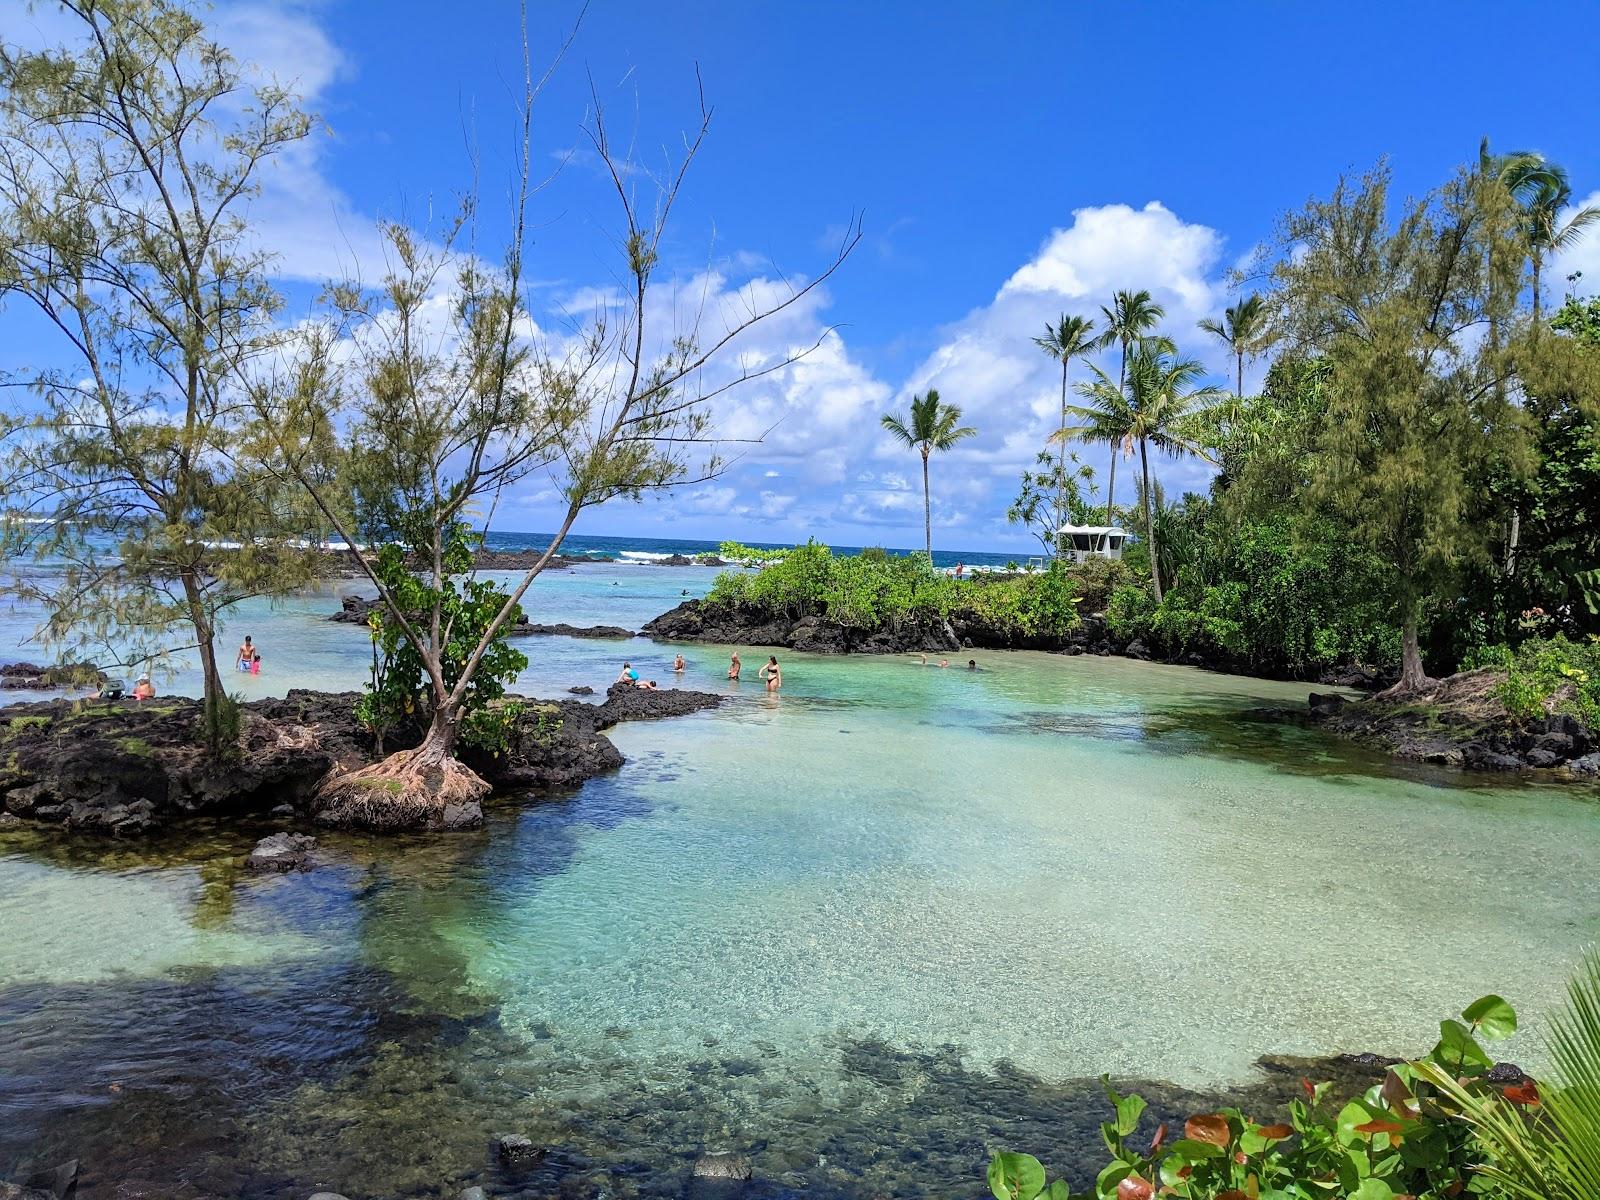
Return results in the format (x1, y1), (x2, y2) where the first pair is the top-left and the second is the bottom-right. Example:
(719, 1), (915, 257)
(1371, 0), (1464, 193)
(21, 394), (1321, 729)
(1035, 150), (1600, 694)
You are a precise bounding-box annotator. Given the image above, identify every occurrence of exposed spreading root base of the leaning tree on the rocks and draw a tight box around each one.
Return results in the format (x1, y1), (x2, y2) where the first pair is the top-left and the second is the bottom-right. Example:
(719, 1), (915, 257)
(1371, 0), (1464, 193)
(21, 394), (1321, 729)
(312, 750), (490, 834)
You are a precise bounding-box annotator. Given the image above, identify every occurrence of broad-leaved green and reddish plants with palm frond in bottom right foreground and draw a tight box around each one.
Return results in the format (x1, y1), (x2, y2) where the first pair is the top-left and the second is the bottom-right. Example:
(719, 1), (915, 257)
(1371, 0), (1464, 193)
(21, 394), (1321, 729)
(989, 950), (1600, 1200)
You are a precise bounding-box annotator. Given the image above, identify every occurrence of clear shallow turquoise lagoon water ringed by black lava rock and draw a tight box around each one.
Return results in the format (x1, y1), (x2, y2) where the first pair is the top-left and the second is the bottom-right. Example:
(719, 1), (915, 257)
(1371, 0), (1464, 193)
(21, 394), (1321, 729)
(0, 566), (1600, 1200)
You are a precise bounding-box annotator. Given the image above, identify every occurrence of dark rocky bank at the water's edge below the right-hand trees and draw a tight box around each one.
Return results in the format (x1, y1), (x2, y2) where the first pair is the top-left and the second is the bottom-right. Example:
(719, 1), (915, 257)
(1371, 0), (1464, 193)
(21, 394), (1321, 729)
(1307, 667), (1600, 779)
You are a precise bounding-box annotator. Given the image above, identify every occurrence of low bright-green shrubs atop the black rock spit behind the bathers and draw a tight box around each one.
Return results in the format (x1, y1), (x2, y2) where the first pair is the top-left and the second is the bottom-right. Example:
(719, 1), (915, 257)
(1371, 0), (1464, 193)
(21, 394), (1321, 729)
(706, 541), (1078, 638)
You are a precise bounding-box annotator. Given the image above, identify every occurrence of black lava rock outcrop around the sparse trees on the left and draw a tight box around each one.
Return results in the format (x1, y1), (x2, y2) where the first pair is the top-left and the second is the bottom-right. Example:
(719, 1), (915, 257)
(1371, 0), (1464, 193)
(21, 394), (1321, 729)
(0, 685), (722, 837)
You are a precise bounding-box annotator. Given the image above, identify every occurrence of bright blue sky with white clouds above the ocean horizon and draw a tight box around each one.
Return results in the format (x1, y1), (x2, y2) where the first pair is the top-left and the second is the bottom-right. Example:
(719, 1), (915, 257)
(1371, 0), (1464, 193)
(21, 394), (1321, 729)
(0, 0), (1600, 549)
